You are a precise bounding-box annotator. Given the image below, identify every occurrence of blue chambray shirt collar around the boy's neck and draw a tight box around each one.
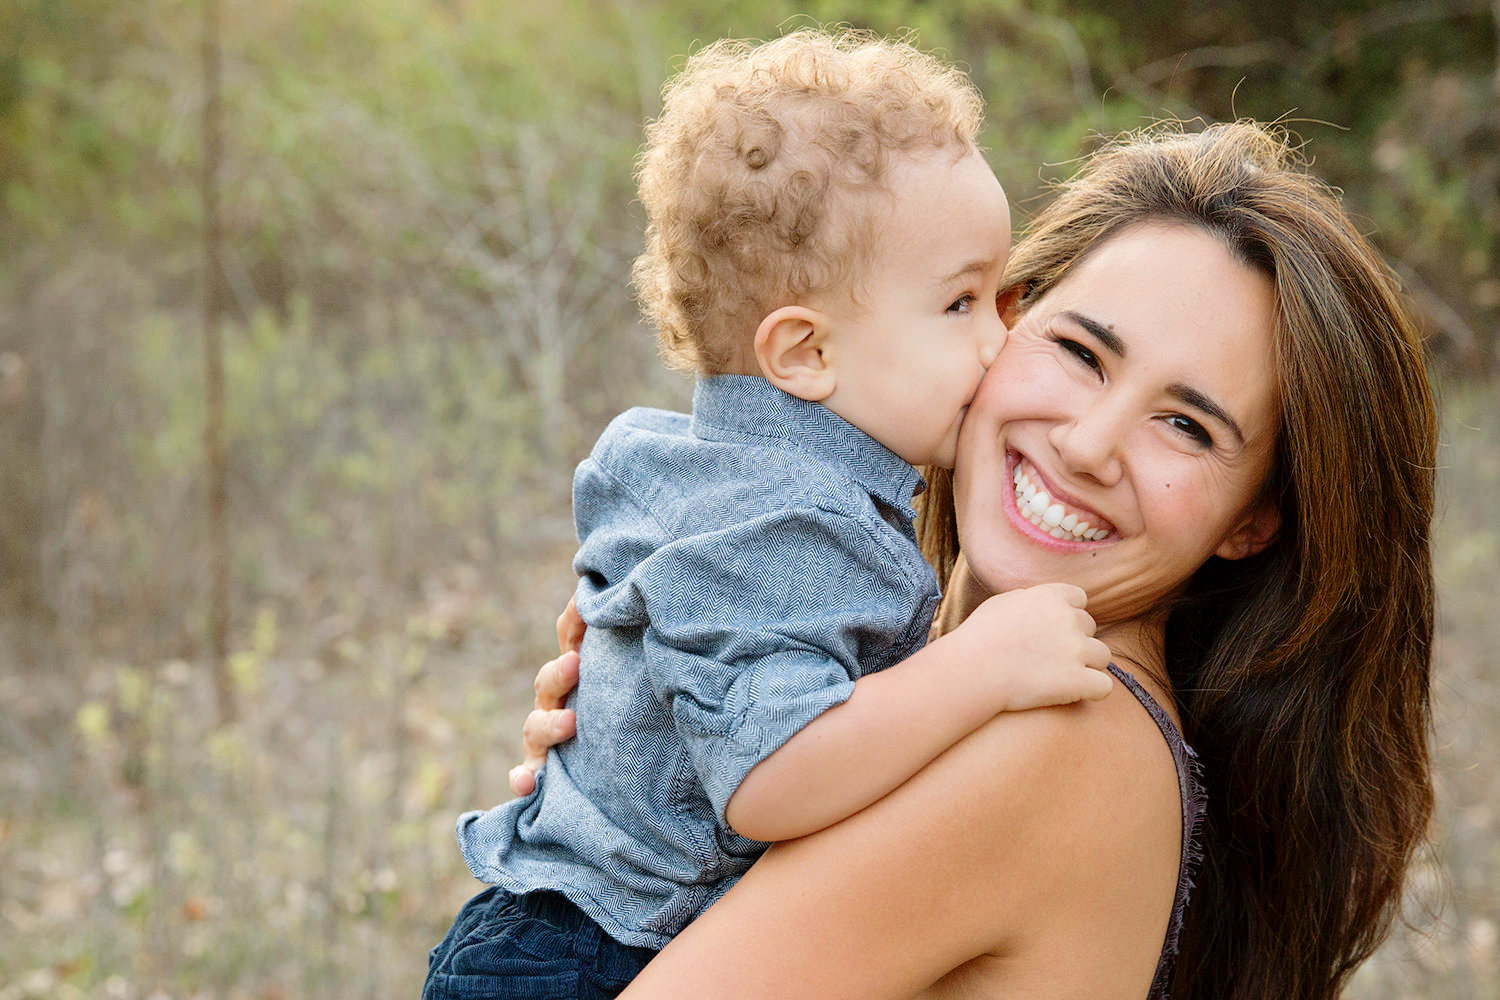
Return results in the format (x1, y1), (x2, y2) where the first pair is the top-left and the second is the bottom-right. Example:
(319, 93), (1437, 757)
(693, 375), (927, 517)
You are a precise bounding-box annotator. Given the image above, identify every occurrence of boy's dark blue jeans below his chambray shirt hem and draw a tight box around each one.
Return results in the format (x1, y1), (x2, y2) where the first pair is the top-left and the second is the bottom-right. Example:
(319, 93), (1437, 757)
(422, 886), (656, 1000)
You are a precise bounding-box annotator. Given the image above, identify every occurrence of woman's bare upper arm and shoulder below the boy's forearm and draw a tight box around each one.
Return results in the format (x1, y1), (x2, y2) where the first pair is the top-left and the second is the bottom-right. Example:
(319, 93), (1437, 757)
(624, 687), (1181, 1000)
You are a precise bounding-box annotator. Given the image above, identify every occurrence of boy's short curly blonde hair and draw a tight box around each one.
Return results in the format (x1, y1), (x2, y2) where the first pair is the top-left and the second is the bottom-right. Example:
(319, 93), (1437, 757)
(633, 28), (984, 375)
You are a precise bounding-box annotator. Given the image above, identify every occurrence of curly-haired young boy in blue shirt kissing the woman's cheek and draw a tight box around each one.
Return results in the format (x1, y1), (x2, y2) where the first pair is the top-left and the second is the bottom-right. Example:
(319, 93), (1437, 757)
(425, 31), (1110, 997)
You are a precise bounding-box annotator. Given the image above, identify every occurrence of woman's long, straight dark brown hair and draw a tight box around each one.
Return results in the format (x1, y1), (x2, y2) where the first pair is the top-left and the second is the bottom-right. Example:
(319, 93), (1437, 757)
(921, 123), (1437, 1000)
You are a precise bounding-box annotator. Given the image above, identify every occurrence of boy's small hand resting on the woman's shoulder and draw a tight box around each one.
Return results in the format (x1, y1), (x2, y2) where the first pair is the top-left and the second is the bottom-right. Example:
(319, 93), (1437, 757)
(939, 583), (1115, 712)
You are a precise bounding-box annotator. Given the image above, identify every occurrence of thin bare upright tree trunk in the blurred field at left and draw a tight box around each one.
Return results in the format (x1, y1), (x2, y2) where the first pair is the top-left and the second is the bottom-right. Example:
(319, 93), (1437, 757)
(203, 0), (239, 723)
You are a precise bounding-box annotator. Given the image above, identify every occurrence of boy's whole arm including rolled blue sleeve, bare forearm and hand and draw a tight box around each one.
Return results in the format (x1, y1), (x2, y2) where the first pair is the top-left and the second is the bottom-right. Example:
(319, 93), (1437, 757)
(633, 510), (1112, 840)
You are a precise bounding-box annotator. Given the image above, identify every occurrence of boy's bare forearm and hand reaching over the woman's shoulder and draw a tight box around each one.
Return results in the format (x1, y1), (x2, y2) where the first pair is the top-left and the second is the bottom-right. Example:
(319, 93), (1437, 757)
(725, 583), (1112, 841)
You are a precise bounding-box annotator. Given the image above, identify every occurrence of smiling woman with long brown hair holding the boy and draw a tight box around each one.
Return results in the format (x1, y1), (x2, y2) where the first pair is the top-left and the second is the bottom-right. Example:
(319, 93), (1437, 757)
(510, 124), (1436, 1000)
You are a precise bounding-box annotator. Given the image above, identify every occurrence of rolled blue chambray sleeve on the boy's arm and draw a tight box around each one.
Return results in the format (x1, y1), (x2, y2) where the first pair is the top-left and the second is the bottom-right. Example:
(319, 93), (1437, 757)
(633, 508), (926, 829)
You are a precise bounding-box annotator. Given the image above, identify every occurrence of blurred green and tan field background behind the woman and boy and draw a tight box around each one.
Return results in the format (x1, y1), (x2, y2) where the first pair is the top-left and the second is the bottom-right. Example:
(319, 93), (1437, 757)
(0, 0), (1500, 1000)
